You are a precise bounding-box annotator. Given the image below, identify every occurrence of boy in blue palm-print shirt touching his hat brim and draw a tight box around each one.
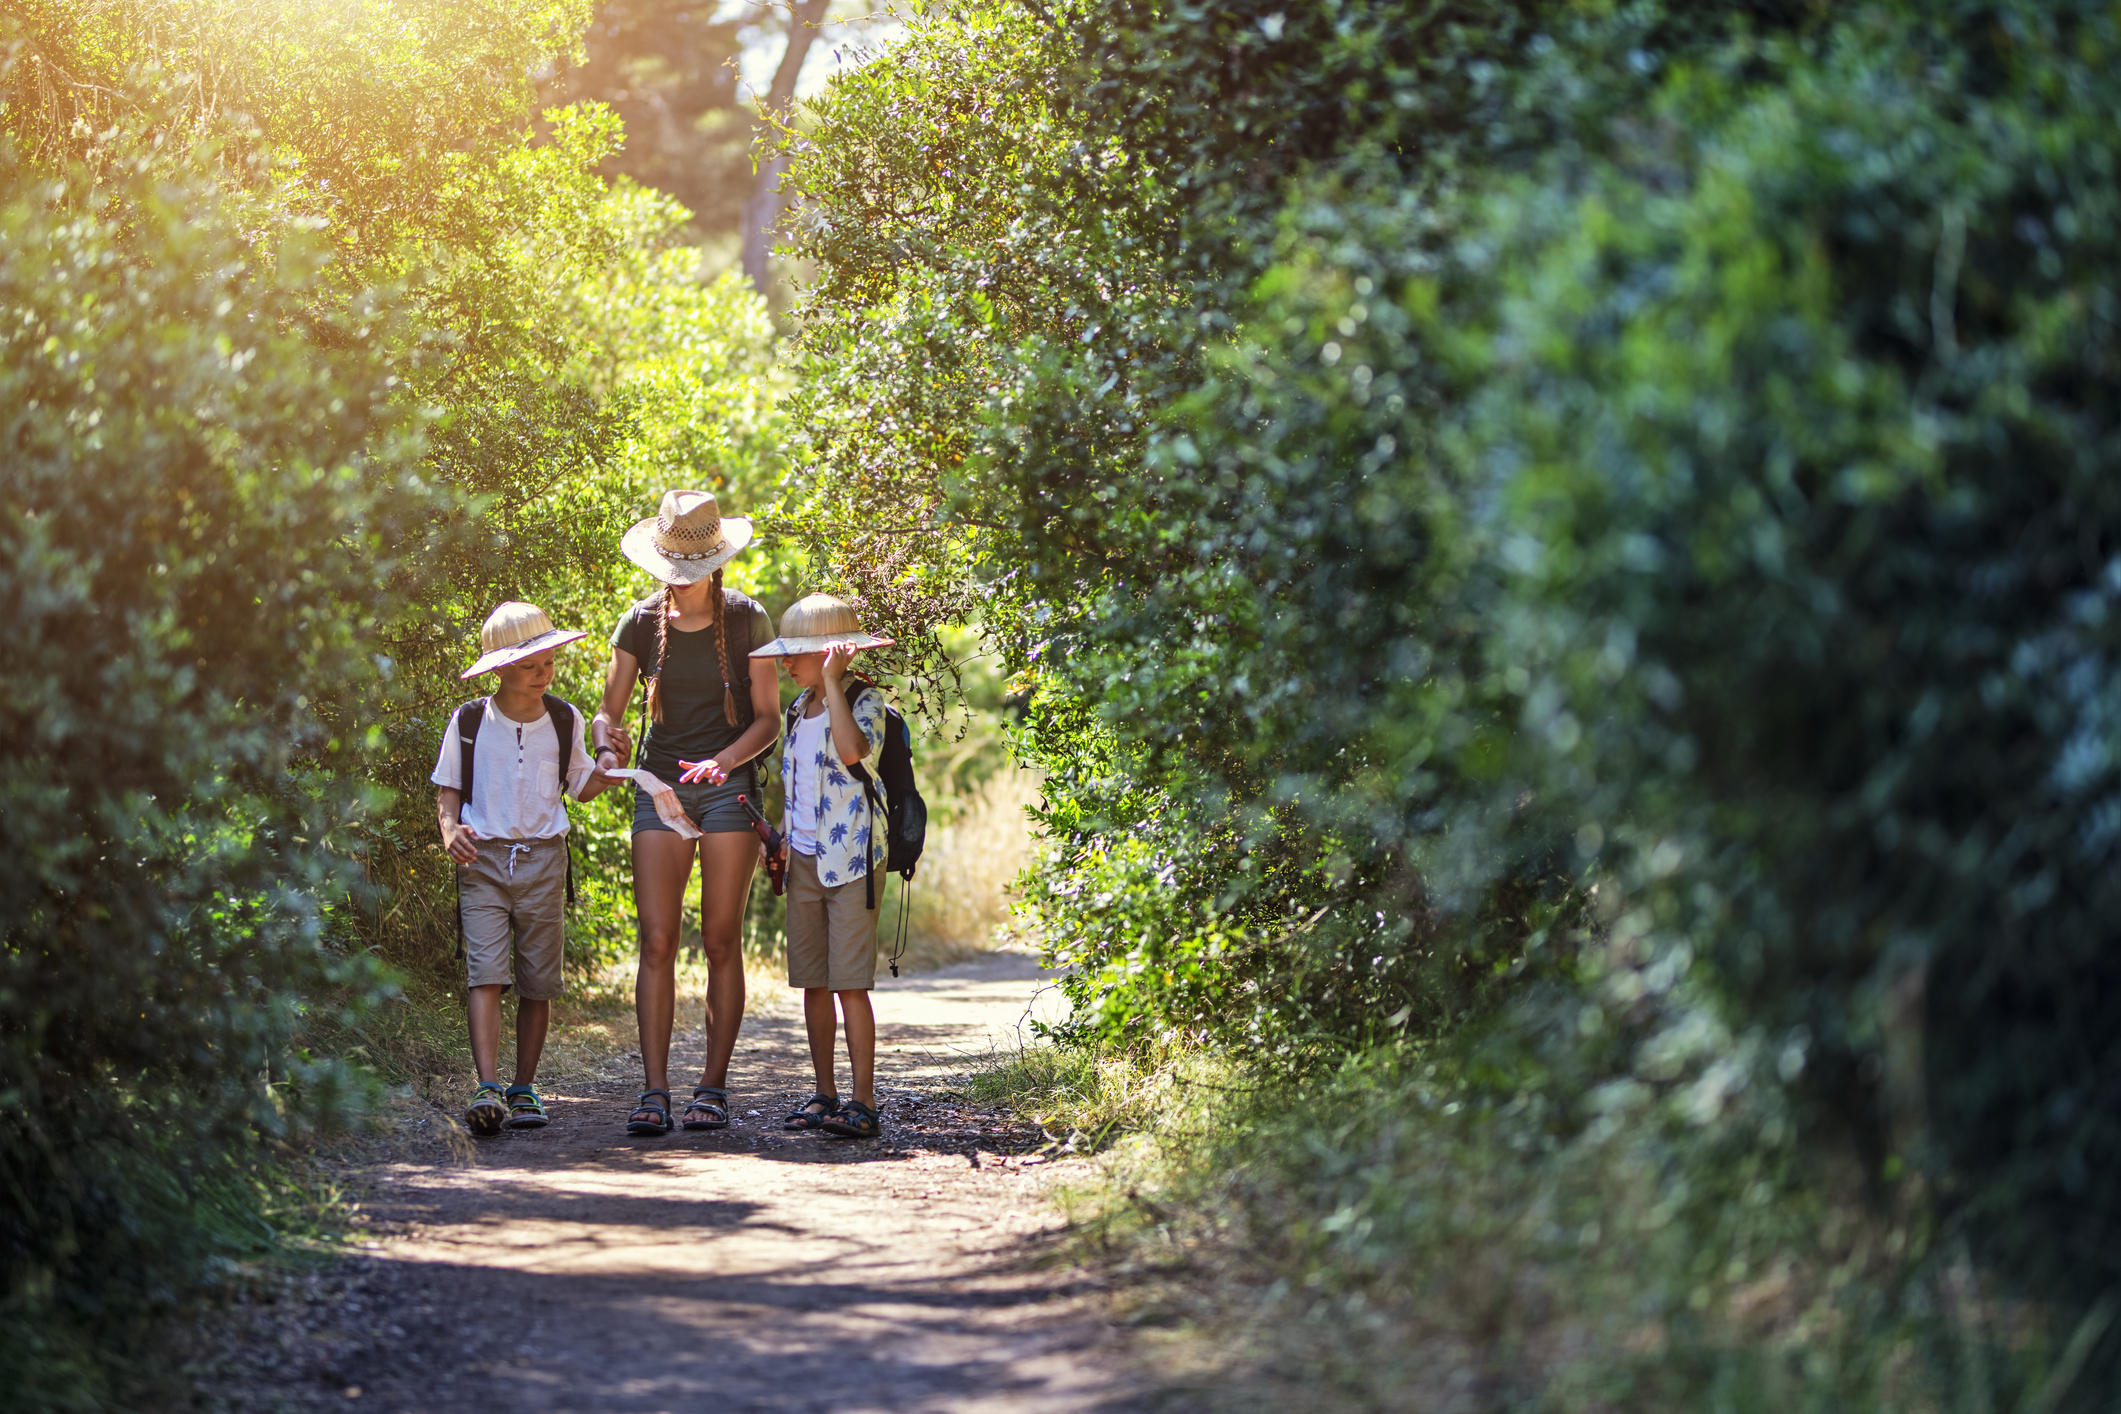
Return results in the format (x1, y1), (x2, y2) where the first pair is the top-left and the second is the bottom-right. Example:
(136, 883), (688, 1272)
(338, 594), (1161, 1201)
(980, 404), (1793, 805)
(751, 594), (891, 1138)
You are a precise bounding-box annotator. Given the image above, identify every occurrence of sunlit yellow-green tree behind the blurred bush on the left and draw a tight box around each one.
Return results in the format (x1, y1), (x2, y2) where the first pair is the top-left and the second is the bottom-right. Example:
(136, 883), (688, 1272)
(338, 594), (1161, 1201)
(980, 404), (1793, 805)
(4, 0), (797, 982)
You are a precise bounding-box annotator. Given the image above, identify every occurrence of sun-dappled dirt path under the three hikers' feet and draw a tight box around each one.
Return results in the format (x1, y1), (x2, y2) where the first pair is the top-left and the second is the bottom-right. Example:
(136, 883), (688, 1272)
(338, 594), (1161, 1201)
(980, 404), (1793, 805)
(190, 954), (1145, 1414)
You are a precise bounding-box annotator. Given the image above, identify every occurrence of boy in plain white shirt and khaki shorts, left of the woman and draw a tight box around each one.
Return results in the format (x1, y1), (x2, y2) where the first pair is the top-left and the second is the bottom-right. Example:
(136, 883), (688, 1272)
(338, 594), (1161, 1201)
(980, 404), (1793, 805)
(431, 602), (626, 1136)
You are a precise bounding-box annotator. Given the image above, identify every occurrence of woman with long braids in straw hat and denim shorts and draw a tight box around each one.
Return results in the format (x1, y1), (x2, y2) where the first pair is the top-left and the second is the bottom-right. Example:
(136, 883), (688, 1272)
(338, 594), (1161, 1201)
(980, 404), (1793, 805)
(592, 492), (781, 1134)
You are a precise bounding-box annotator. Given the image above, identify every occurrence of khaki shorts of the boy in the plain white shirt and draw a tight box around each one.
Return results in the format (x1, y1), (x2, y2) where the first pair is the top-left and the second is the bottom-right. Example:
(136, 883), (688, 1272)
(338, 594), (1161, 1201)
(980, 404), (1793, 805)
(456, 835), (566, 1001)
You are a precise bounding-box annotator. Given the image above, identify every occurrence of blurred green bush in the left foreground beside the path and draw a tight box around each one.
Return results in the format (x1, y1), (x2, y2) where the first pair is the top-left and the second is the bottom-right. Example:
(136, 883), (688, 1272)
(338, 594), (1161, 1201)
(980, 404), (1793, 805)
(0, 91), (450, 1408)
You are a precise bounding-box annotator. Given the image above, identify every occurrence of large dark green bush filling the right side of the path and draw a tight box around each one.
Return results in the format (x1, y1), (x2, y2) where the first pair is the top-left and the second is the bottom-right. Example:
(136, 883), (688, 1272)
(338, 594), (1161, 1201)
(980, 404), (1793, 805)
(795, 0), (2121, 1397)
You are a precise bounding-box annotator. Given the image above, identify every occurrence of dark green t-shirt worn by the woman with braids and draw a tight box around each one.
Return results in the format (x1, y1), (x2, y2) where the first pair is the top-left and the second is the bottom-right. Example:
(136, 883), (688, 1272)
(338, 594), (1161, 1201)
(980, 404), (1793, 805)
(611, 589), (774, 782)
